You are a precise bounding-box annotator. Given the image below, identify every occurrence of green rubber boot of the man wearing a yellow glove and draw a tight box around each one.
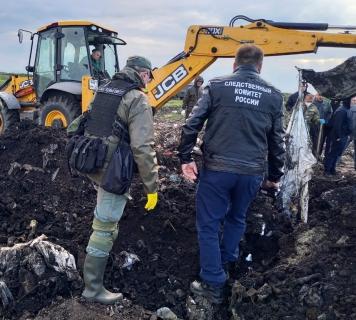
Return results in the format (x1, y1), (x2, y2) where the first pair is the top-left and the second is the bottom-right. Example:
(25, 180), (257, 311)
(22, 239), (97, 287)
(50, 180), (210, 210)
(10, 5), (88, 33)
(82, 254), (122, 304)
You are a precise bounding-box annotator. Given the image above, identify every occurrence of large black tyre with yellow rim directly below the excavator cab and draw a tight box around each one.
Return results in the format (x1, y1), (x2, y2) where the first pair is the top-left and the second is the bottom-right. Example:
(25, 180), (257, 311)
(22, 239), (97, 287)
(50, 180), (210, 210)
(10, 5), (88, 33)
(39, 95), (80, 128)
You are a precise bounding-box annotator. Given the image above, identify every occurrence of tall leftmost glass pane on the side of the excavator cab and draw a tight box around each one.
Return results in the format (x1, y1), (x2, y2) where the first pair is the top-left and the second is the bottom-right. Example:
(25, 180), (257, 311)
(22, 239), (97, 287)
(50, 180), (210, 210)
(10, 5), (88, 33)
(34, 29), (57, 97)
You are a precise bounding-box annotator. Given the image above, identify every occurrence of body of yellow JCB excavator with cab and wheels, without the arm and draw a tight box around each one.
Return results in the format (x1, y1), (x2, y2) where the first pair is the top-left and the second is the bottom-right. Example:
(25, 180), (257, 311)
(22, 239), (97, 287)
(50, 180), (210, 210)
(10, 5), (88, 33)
(0, 21), (126, 133)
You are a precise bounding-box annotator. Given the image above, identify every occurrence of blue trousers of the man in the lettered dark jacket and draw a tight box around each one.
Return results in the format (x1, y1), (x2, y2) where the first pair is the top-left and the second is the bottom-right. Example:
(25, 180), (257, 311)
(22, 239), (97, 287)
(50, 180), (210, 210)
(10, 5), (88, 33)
(196, 170), (262, 286)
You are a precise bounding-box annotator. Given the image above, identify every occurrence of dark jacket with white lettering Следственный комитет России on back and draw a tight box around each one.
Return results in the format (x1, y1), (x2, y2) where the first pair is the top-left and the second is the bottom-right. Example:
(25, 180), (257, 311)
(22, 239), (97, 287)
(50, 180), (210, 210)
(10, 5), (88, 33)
(178, 65), (285, 182)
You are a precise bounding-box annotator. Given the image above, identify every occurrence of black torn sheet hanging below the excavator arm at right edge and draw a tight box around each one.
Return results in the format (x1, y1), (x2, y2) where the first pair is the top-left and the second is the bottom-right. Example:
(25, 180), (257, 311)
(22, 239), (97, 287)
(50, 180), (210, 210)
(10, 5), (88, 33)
(301, 56), (356, 100)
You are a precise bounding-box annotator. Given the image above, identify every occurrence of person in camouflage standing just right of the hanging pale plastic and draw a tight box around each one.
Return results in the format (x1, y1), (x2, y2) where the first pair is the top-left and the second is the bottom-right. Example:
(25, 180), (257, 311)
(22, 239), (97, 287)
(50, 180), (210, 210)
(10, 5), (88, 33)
(303, 93), (320, 156)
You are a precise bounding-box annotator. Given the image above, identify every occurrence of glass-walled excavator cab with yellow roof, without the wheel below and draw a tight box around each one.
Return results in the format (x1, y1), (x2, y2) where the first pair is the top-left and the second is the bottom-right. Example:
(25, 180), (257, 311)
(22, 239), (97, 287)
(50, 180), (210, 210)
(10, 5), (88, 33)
(30, 22), (125, 97)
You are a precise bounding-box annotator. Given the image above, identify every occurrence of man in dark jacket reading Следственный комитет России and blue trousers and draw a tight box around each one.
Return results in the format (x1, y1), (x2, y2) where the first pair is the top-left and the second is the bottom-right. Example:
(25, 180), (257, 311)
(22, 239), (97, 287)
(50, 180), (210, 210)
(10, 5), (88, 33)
(178, 45), (285, 303)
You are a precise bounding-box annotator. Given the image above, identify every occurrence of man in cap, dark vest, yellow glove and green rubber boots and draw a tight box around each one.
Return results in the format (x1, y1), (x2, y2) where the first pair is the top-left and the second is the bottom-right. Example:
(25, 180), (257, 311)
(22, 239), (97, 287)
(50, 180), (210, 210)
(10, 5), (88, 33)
(68, 56), (158, 304)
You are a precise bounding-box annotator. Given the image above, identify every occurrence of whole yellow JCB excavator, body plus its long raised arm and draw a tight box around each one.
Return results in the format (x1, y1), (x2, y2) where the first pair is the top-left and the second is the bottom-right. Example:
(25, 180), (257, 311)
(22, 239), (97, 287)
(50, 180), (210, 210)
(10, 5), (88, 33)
(0, 16), (356, 133)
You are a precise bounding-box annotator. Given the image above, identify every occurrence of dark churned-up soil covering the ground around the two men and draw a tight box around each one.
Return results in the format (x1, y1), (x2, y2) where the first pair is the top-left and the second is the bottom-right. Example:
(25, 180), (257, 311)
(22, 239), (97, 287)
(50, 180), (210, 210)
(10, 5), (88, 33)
(0, 118), (356, 320)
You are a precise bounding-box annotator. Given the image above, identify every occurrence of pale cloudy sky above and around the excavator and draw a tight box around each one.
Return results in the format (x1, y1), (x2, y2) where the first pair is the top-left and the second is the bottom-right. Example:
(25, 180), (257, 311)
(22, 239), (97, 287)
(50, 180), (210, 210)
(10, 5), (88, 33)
(0, 0), (356, 92)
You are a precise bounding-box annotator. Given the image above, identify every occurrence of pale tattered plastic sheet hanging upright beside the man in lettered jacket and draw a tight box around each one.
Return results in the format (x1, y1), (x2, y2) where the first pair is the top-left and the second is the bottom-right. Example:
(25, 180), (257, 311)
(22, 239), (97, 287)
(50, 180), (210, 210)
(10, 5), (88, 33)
(278, 102), (317, 222)
